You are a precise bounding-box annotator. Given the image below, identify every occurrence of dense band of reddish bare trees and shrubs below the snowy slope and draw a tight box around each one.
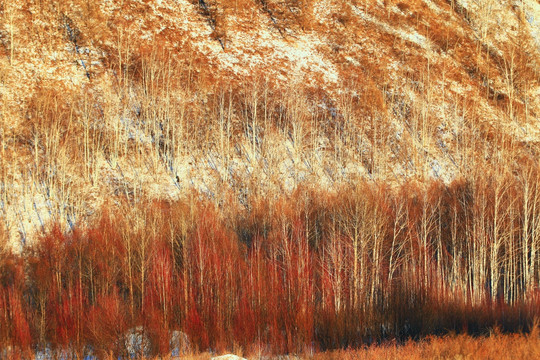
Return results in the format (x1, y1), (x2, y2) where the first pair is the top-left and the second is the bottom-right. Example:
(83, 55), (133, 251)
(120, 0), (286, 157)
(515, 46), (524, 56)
(0, 174), (540, 355)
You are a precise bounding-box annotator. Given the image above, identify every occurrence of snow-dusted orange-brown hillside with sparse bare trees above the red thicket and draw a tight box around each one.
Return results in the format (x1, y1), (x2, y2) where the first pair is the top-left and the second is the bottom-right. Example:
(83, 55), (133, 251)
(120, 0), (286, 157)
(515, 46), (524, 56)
(0, 0), (540, 244)
